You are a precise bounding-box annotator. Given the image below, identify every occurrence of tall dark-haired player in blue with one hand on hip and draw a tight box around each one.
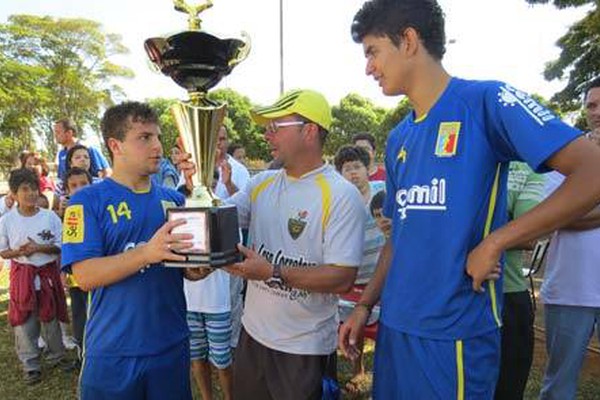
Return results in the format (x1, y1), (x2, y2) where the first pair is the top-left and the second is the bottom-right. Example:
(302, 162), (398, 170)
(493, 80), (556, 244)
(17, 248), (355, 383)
(340, 0), (600, 399)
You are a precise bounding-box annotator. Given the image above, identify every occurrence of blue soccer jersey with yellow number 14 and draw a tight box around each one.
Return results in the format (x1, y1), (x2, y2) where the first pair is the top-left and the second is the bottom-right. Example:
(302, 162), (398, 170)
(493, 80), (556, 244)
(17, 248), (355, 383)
(62, 178), (188, 356)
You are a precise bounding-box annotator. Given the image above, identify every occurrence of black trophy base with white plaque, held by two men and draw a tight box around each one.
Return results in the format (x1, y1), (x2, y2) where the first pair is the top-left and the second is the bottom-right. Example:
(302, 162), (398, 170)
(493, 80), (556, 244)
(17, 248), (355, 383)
(163, 206), (241, 268)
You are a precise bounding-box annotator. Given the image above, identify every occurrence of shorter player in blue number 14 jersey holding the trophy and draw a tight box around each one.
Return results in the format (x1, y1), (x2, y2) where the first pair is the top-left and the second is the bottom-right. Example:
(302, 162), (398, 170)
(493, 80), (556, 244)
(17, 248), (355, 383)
(62, 102), (209, 400)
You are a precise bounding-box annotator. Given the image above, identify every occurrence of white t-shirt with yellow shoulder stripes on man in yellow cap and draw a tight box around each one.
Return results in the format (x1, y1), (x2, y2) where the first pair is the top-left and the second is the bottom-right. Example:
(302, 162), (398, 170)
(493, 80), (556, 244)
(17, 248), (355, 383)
(229, 165), (366, 355)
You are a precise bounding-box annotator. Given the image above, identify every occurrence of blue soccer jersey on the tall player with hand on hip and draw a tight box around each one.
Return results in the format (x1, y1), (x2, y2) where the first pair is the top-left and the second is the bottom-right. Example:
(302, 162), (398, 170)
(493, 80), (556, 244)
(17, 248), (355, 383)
(381, 78), (579, 340)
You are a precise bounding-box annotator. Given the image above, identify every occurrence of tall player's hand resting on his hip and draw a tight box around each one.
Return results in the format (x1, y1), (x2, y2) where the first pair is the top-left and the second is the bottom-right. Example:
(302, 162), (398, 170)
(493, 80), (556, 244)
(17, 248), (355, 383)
(466, 236), (502, 293)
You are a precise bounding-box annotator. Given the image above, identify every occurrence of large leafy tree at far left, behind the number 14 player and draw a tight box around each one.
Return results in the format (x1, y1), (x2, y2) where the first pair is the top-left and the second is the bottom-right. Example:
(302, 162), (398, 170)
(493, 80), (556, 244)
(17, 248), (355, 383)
(0, 15), (133, 156)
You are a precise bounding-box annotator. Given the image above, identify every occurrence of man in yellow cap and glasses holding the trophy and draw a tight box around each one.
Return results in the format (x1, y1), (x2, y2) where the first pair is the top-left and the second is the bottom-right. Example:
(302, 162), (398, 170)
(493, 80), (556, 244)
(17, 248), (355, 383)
(227, 90), (366, 400)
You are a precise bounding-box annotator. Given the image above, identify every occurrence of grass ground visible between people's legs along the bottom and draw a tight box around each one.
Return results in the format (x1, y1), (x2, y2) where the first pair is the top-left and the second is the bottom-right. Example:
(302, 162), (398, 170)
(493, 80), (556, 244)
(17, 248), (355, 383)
(0, 269), (600, 400)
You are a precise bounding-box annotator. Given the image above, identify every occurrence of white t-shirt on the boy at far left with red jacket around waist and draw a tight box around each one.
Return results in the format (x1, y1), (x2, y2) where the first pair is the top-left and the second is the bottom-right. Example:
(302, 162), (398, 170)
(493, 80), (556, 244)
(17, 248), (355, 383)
(0, 207), (62, 290)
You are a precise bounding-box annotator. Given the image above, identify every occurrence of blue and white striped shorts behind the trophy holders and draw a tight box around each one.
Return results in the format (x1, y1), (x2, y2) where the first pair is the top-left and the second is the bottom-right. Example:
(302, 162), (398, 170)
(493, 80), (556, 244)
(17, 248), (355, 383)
(187, 311), (231, 369)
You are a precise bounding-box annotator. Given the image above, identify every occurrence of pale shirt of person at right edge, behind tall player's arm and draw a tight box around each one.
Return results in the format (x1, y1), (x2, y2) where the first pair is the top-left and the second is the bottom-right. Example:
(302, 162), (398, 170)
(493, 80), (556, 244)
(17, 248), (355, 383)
(541, 172), (600, 307)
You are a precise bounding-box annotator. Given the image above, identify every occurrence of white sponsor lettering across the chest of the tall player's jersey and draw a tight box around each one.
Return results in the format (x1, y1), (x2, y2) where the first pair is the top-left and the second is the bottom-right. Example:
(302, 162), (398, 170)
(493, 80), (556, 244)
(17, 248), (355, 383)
(396, 178), (447, 219)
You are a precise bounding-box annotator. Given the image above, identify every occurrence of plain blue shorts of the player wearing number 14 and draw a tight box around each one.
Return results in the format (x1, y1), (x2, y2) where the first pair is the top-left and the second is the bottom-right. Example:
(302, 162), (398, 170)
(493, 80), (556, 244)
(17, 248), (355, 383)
(79, 340), (192, 400)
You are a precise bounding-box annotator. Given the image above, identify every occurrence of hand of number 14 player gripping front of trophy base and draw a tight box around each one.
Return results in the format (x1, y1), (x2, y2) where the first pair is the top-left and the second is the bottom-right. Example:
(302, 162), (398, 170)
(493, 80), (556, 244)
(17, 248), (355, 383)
(140, 219), (194, 265)
